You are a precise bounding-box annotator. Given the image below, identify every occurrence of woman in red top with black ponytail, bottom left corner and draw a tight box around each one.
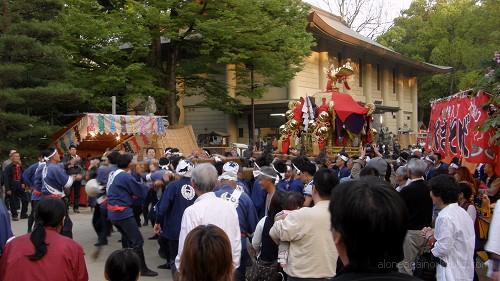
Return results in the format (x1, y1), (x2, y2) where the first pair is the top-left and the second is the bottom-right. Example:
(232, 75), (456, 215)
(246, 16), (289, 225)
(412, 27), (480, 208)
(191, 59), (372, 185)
(0, 198), (89, 281)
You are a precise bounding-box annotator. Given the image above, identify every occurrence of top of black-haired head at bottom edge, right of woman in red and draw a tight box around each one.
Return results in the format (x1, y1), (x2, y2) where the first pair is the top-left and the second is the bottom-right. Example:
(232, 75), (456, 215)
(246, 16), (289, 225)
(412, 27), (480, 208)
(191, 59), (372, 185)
(104, 249), (141, 281)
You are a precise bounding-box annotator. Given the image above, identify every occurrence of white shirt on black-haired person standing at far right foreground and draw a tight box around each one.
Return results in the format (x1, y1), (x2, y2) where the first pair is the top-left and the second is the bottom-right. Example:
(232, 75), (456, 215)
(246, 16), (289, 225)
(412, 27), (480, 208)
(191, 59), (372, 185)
(432, 203), (476, 281)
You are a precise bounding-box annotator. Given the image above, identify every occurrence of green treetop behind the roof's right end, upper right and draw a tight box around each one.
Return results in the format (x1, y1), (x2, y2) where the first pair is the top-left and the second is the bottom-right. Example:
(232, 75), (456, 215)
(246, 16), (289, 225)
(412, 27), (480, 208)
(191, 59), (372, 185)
(377, 0), (500, 120)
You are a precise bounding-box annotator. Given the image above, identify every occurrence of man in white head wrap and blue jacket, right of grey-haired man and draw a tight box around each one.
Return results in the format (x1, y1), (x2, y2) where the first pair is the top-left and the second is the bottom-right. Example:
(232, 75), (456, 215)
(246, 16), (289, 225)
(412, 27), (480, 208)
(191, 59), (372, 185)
(215, 161), (258, 280)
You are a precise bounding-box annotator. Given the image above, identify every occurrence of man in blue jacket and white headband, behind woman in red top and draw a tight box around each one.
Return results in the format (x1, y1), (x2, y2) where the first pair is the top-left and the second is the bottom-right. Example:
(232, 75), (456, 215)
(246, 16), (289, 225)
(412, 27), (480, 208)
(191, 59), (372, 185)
(42, 149), (82, 238)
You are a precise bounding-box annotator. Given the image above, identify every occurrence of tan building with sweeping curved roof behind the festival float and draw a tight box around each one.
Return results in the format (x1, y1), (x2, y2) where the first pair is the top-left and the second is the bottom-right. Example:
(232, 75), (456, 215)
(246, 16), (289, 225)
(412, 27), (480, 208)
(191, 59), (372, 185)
(179, 8), (452, 143)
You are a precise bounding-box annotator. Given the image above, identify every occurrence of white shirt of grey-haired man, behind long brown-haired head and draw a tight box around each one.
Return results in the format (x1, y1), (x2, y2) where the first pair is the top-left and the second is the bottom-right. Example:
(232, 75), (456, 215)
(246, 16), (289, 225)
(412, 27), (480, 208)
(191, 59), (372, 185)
(175, 192), (241, 269)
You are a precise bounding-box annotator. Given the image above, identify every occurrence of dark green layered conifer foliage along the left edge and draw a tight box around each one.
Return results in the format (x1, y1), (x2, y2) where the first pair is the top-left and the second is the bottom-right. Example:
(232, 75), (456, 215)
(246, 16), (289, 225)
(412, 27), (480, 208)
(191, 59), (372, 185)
(0, 0), (85, 159)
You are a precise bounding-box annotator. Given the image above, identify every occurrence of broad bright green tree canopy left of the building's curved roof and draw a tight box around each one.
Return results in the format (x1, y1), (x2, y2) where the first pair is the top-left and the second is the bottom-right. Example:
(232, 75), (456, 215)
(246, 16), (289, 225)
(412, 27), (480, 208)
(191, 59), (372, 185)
(63, 0), (313, 123)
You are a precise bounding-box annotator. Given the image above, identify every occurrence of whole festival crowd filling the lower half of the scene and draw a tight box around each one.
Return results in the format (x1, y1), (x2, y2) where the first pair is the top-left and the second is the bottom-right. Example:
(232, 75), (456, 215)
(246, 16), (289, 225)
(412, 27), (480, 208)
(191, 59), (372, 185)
(0, 142), (500, 281)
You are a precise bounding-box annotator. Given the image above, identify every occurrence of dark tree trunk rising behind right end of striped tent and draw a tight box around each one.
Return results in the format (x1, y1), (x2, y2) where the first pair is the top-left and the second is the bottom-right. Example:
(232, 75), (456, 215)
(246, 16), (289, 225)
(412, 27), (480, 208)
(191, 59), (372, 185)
(165, 42), (179, 125)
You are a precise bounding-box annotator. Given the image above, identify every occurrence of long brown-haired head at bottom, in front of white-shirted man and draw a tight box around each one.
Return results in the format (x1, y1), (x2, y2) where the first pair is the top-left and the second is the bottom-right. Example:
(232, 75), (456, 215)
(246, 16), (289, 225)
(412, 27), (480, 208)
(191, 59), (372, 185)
(178, 224), (234, 281)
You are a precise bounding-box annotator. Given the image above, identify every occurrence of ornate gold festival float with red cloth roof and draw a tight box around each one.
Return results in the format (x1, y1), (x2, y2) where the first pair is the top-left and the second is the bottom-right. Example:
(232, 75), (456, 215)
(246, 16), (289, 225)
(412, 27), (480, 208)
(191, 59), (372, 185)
(279, 62), (375, 155)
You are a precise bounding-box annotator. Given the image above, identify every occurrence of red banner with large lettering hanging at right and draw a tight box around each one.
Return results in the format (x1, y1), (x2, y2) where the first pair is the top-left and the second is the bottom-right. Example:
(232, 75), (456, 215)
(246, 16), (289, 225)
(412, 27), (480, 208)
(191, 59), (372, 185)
(426, 89), (500, 163)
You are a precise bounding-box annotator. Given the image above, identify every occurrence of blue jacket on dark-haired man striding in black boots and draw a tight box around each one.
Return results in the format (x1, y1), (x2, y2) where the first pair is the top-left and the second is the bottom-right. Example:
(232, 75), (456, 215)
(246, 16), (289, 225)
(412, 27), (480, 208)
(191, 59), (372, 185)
(107, 170), (148, 221)
